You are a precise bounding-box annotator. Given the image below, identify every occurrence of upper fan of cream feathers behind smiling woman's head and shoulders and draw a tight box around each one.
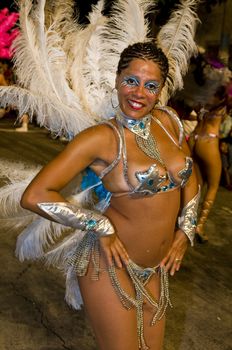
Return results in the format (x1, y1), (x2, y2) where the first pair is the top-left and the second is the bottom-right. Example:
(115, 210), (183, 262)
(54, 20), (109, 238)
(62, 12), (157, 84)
(0, 0), (197, 135)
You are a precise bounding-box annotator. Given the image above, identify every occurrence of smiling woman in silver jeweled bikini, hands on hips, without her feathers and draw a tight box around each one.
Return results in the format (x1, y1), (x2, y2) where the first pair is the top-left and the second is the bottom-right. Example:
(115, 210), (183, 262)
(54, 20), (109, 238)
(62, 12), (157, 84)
(21, 42), (199, 350)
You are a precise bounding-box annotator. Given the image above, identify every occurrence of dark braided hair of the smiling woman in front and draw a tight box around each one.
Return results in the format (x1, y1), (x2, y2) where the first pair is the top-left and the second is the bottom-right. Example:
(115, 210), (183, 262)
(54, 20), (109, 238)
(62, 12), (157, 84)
(117, 41), (168, 83)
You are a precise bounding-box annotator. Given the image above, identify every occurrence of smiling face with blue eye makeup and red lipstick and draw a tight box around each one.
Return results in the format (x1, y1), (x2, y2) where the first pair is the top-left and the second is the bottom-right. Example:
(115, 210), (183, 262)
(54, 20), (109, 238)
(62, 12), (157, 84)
(116, 58), (163, 119)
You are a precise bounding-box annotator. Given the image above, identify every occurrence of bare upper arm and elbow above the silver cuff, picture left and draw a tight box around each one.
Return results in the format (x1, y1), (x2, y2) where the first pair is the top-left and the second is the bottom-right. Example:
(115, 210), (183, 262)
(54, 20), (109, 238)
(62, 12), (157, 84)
(21, 125), (112, 218)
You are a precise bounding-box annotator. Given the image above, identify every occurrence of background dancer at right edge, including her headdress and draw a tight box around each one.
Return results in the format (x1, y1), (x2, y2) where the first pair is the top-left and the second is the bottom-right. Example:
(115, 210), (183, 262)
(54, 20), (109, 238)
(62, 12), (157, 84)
(177, 54), (231, 243)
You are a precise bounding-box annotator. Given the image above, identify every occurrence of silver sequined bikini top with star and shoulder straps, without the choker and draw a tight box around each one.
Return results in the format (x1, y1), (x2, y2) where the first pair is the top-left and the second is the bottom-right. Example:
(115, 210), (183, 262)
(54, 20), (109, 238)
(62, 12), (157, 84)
(99, 107), (193, 197)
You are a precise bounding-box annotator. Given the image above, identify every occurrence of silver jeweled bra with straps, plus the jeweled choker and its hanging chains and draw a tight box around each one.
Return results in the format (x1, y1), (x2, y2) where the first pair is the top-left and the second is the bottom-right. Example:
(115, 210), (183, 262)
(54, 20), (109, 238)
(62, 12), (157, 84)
(95, 107), (193, 197)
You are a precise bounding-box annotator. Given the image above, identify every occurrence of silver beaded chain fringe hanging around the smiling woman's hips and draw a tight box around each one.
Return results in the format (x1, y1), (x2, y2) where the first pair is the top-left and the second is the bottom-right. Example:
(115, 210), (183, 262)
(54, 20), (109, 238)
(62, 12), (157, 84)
(67, 232), (172, 350)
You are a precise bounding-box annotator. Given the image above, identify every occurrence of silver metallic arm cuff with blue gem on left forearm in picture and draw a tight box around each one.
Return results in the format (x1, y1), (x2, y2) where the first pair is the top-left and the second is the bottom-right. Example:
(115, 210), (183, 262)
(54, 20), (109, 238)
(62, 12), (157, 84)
(37, 202), (115, 237)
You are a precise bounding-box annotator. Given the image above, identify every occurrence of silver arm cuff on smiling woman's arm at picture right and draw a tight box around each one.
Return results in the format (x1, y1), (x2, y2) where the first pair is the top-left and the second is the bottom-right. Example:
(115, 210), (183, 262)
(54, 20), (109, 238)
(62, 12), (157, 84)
(178, 186), (201, 246)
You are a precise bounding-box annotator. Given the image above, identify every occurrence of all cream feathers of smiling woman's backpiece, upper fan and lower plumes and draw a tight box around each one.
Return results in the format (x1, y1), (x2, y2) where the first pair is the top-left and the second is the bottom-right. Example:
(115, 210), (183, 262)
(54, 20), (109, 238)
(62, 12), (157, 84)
(0, 0), (197, 308)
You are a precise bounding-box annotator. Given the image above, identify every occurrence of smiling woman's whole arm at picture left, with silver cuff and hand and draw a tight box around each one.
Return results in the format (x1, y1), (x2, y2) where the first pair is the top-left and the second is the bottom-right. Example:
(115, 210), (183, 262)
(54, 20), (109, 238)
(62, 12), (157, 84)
(21, 125), (129, 268)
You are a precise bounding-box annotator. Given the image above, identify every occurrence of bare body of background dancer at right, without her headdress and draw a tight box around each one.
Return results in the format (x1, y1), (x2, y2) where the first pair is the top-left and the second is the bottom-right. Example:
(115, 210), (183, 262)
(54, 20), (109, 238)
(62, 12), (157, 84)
(190, 86), (226, 243)
